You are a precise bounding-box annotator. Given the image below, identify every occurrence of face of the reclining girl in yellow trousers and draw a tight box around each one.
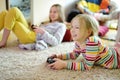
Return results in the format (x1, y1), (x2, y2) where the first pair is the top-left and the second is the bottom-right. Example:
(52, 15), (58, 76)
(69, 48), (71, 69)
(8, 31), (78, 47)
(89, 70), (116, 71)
(49, 6), (59, 22)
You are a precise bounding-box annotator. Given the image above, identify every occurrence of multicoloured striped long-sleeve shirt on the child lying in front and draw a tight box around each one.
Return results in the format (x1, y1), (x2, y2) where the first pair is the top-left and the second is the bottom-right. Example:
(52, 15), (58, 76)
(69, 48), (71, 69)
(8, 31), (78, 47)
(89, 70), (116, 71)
(61, 36), (118, 70)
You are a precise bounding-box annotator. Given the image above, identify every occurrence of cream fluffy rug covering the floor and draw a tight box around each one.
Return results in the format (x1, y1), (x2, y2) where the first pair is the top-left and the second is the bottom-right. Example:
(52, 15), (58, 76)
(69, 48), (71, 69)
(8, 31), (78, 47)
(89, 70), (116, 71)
(0, 42), (120, 80)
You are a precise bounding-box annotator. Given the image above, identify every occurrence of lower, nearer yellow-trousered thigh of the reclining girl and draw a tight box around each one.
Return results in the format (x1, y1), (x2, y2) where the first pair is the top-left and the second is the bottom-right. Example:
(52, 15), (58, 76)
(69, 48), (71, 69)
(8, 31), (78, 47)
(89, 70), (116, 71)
(13, 22), (36, 44)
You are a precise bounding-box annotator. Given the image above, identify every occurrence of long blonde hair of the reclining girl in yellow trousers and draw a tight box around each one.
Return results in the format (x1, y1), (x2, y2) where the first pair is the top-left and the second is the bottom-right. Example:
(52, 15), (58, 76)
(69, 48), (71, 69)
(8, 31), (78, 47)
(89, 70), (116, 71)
(49, 4), (65, 22)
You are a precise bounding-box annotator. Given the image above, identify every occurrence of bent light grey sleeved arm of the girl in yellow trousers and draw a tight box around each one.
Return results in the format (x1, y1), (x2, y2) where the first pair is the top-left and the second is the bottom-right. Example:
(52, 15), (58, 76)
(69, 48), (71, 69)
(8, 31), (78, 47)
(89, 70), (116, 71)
(40, 23), (66, 46)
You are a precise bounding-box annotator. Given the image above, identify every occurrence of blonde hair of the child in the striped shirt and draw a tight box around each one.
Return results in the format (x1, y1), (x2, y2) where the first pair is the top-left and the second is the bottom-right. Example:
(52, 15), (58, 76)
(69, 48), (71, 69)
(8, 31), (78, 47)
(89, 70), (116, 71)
(74, 14), (99, 36)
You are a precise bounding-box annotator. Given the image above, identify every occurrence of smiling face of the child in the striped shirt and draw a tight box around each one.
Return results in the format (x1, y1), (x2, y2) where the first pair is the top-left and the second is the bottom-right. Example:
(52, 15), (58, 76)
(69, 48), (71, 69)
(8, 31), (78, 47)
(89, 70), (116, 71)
(71, 18), (89, 42)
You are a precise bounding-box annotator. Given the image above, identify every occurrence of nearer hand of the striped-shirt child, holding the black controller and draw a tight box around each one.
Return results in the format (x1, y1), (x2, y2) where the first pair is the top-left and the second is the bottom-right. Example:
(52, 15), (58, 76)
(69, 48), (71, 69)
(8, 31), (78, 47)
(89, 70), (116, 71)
(48, 58), (67, 70)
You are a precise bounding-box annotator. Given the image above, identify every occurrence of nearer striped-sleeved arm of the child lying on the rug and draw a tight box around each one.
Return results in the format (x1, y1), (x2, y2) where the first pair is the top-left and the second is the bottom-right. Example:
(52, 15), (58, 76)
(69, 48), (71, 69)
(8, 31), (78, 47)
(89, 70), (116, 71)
(66, 36), (99, 70)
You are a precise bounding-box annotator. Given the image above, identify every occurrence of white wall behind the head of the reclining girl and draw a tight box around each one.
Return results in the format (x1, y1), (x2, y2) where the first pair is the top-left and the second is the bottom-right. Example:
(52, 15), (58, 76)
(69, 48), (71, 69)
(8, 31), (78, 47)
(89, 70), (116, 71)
(31, 0), (76, 24)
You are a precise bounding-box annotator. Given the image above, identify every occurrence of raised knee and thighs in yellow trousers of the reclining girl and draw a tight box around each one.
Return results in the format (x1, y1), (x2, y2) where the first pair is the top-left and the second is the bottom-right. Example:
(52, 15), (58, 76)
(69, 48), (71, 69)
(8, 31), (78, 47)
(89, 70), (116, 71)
(8, 8), (36, 44)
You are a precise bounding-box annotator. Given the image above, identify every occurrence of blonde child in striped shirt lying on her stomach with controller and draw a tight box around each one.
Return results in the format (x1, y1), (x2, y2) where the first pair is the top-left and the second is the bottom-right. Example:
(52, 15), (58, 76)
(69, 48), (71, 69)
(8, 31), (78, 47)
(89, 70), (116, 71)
(48, 14), (120, 70)
